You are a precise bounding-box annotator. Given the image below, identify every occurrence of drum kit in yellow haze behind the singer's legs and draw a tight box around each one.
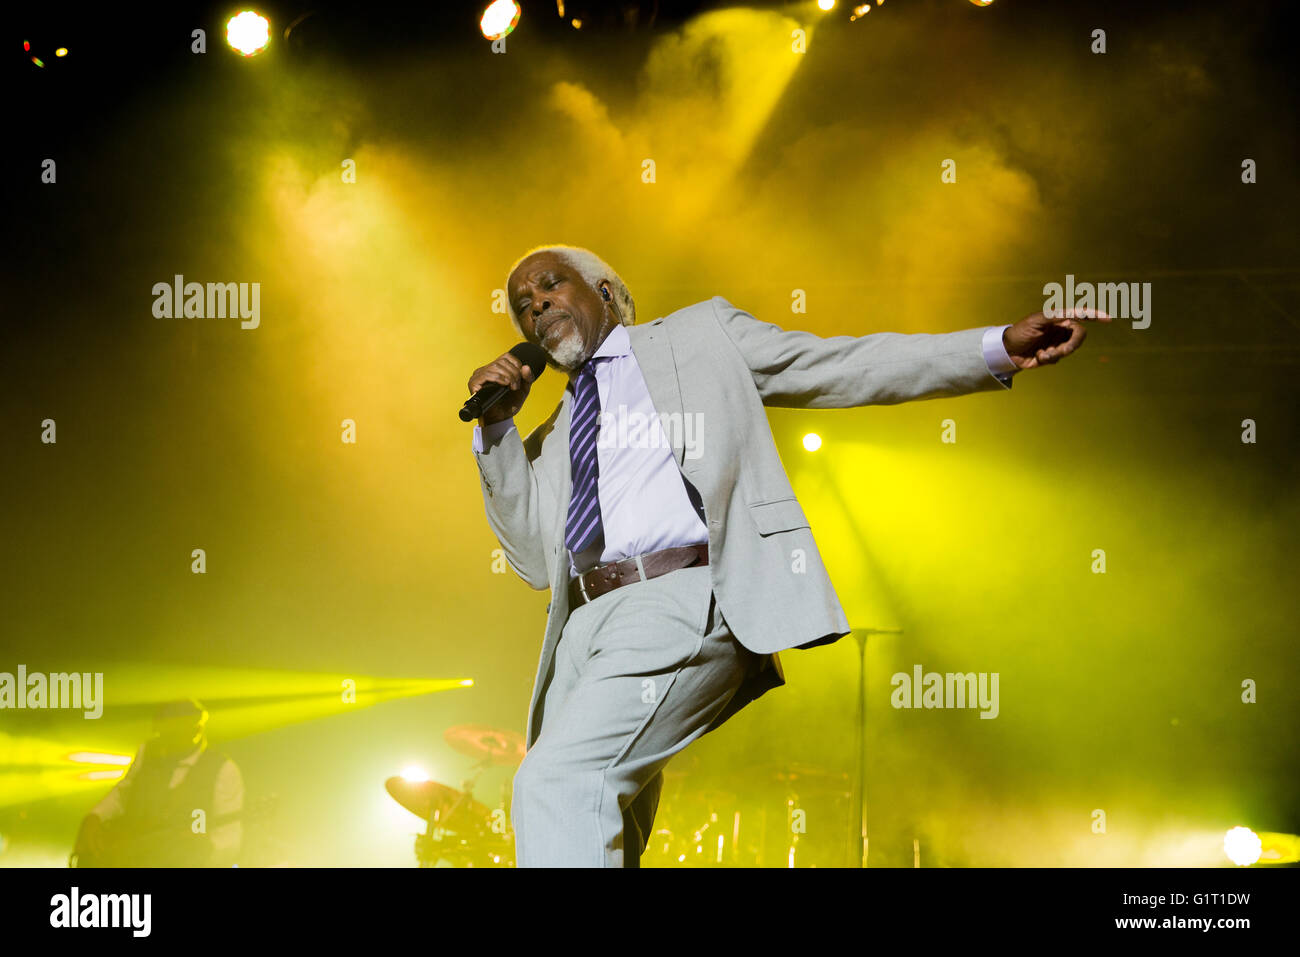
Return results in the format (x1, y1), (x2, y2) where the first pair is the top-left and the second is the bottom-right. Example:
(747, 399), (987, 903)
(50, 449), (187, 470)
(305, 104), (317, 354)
(385, 724), (852, 867)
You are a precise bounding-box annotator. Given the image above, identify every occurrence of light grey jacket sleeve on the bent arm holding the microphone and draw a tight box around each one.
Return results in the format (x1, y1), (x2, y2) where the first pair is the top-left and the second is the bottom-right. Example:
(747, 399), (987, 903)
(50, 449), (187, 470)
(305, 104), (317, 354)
(473, 421), (550, 590)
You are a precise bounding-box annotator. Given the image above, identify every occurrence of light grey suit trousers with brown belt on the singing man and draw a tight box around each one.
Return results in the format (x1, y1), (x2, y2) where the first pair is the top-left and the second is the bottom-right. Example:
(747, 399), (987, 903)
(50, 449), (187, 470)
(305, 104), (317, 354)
(511, 567), (761, 867)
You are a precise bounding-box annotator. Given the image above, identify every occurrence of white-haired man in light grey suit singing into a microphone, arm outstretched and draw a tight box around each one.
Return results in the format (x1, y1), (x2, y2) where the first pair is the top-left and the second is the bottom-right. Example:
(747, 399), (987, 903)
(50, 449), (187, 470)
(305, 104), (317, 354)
(469, 246), (1108, 867)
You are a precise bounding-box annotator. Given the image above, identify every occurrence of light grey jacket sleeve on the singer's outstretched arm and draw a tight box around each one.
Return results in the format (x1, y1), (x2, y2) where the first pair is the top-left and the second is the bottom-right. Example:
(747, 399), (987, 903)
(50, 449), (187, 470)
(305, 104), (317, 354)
(711, 296), (1010, 408)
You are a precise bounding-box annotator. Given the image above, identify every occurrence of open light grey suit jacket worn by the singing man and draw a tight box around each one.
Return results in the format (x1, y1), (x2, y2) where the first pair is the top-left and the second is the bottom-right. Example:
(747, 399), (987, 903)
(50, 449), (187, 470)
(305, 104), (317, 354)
(475, 296), (1009, 746)
